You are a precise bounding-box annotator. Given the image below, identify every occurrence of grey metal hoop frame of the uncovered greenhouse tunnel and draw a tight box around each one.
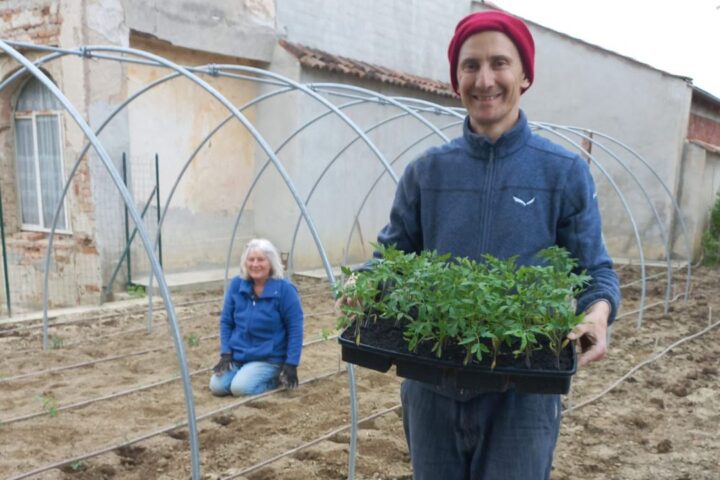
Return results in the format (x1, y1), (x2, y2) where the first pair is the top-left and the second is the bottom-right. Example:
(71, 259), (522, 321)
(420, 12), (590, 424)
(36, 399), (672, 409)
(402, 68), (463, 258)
(0, 40), (692, 480)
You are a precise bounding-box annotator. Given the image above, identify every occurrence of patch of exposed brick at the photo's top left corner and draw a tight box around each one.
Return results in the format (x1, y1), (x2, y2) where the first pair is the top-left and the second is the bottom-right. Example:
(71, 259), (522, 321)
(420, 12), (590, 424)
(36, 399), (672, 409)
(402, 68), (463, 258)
(0, 0), (62, 45)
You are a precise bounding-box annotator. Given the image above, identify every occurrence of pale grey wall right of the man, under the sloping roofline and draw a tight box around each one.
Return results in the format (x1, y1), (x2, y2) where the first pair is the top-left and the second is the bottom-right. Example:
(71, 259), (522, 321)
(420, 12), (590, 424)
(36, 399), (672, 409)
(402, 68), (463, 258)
(522, 25), (692, 260)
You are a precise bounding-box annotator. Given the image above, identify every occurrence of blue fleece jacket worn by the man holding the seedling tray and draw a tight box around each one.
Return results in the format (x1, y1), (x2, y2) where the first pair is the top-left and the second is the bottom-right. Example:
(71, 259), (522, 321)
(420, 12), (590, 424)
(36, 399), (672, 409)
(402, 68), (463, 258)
(378, 111), (620, 322)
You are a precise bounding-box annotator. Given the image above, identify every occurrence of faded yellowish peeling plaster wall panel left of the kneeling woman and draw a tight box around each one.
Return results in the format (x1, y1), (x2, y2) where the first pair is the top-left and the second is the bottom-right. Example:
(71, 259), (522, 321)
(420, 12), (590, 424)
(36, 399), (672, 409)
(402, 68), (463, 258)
(127, 37), (258, 274)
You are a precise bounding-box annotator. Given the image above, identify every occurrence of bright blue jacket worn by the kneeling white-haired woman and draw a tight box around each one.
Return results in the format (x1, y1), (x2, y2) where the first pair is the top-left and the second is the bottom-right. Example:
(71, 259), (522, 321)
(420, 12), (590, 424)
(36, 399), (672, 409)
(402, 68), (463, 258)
(220, 277), (303, 365)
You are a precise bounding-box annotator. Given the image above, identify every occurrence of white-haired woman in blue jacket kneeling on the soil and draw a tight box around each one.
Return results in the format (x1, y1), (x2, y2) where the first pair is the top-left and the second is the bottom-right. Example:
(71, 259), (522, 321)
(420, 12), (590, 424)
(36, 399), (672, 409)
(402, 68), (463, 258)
(210, 238), (303, 396)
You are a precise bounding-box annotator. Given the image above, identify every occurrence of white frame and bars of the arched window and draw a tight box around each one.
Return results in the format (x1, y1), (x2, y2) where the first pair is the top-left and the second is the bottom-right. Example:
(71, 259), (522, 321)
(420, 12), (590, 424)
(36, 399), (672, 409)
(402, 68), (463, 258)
(14, 110), (72, 235)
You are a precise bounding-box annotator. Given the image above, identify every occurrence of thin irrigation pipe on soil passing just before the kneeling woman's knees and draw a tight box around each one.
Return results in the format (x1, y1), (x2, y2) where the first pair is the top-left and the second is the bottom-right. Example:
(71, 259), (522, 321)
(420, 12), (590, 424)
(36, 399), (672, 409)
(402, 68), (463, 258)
(6, 370), (346, 480)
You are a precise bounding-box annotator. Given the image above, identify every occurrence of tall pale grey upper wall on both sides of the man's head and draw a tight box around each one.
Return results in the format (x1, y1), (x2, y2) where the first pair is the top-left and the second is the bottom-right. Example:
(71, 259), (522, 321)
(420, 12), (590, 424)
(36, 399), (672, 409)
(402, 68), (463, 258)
(278, 0), (692, 260)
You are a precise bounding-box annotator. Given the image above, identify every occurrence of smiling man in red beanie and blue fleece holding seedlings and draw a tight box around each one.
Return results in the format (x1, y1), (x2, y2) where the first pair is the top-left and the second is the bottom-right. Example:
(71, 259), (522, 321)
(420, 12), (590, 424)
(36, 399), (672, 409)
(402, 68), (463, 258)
(378, 7), (620, 480)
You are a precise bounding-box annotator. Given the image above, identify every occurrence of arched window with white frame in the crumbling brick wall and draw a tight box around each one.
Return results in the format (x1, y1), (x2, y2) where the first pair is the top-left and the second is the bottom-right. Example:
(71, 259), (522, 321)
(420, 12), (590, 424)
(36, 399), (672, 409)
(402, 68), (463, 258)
(15, 78), (68, 231)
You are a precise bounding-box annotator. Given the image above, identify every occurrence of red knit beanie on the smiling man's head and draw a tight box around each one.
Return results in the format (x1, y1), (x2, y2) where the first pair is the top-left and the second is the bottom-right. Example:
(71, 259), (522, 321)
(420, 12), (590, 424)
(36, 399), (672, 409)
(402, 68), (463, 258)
(448, 10), (535, 93)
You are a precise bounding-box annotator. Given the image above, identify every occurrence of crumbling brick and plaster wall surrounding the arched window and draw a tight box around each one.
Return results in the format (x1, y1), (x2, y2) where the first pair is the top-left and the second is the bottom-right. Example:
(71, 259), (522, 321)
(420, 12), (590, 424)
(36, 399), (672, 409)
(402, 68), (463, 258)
(0, 0), (102, 315)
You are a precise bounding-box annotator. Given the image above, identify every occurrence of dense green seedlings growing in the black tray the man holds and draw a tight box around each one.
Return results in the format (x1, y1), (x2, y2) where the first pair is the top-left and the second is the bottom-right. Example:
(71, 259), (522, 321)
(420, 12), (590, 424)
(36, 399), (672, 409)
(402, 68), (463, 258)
(337, 245), (590, 368)
